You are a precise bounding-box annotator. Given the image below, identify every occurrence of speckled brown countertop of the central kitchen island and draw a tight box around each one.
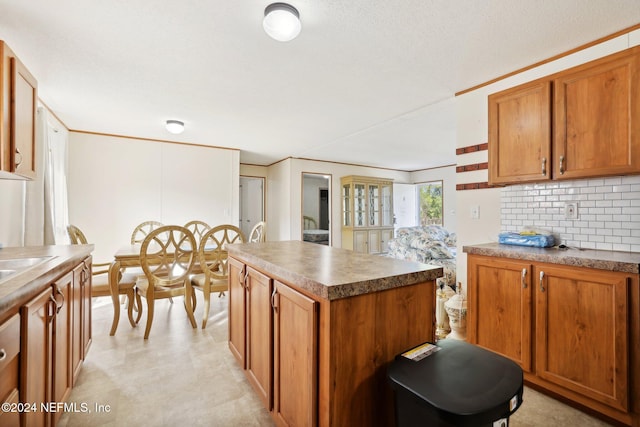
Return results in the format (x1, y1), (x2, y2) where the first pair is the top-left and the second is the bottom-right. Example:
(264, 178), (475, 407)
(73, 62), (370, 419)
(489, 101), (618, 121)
(228, 240), (443, 300)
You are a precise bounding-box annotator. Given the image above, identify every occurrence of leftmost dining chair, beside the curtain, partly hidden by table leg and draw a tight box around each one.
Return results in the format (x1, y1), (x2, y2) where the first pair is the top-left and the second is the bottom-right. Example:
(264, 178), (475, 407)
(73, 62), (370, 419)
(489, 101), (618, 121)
(67, 225), (140, 326)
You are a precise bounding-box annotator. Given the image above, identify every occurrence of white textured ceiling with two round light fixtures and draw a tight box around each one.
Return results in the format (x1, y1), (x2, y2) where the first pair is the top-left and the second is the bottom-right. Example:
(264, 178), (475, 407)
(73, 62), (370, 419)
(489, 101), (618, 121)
(0, 0), (640, 170)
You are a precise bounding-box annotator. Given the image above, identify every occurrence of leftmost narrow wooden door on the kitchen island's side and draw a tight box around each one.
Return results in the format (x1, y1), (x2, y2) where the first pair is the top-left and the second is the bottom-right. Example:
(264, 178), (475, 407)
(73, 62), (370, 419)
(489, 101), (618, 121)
(228, 257), (247, 369)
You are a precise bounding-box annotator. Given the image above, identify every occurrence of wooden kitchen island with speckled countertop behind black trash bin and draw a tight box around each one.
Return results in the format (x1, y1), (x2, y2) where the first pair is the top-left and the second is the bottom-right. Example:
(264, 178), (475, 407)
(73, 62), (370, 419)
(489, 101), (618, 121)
(229, 241), (443, 426)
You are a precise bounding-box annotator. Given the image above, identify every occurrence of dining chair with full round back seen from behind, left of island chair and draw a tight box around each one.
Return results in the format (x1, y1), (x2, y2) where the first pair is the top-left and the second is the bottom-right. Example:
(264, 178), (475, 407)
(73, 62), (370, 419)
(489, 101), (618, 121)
(136, 225), (198, 339)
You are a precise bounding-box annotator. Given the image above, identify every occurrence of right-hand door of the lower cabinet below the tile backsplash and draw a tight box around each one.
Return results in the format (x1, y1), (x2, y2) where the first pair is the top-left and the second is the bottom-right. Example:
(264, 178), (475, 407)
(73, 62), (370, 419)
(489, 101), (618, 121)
(535, 265), (630, 411)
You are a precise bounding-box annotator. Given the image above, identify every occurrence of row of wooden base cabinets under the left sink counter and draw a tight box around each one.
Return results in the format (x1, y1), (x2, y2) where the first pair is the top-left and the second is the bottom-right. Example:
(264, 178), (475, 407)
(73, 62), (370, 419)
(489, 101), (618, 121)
(5, 257), (91, 427)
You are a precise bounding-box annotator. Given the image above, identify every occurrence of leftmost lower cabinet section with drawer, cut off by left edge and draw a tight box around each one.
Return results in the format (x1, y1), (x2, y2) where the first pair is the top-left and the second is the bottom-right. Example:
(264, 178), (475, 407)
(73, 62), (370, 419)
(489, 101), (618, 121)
(0, 314), (20, 427)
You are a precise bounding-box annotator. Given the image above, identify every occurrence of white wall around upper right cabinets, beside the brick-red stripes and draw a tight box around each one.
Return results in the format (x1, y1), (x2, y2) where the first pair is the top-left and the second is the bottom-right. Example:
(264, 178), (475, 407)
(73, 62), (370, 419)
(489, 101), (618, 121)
(456, 30), (640, 289)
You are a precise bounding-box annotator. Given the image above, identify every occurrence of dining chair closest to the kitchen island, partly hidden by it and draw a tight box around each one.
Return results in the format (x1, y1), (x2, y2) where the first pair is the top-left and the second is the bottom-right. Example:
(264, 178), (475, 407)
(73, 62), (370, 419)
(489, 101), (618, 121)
(191, 224), (245, 329)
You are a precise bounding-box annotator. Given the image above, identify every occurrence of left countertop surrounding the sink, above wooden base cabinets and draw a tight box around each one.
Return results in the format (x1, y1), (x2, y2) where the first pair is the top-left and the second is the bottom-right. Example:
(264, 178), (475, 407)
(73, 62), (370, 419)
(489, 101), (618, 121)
(0, 245), (93, 318)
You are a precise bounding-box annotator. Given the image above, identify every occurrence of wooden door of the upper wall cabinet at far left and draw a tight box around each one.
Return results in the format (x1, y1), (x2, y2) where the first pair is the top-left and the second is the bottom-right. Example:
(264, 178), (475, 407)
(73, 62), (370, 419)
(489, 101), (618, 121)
(11, 57), (38, 178)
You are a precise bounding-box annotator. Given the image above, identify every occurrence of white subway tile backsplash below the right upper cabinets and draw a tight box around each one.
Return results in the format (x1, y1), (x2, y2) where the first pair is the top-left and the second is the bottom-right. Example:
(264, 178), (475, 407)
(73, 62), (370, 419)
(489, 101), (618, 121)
(500, 176), (640, 252)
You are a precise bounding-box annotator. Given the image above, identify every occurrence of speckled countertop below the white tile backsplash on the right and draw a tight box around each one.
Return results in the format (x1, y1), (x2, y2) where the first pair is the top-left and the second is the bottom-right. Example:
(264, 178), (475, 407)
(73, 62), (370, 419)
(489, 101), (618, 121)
(462, 243), (640, 274)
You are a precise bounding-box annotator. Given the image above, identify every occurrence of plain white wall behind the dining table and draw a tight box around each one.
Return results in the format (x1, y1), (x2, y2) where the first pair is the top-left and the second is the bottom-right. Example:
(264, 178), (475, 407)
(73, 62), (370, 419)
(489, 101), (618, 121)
(69, 132), (240, 262)
